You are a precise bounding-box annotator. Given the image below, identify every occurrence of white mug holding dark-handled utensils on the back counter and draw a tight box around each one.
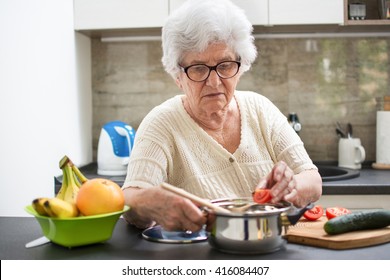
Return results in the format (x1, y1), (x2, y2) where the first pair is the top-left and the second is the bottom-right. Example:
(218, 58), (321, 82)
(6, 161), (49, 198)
(339, 138), (366, 169)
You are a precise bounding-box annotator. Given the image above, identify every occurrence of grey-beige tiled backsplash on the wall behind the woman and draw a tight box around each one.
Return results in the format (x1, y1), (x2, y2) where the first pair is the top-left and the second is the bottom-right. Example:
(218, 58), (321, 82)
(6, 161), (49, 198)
(92, 37), (390, 162)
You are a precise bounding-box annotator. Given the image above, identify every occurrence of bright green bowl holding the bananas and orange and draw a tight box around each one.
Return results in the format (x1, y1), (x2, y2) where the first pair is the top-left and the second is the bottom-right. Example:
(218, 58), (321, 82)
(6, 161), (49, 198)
(25, 205), (130, 248)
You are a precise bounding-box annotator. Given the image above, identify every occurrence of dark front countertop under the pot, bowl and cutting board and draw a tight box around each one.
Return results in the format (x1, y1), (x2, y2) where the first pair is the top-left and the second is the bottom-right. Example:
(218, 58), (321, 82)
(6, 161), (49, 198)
(0, 217), (390, 260)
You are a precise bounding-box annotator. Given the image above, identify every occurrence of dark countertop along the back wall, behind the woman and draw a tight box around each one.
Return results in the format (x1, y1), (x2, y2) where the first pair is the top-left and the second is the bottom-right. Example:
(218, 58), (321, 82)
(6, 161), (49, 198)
(54, 162), (390, 195)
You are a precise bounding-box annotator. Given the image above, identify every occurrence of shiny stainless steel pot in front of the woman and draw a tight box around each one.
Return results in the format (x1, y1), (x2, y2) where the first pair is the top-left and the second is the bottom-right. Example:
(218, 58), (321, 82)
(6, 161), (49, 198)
(206, 198), (313, 254)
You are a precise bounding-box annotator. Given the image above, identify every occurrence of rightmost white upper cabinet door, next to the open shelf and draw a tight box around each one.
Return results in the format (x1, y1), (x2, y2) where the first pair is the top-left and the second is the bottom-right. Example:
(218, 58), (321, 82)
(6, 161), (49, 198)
(269, 0), (344, 25)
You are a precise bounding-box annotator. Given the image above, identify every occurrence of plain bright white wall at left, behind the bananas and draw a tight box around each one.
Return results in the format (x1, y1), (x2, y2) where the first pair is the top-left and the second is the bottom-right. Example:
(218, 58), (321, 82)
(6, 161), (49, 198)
(0, 0), (92, 216)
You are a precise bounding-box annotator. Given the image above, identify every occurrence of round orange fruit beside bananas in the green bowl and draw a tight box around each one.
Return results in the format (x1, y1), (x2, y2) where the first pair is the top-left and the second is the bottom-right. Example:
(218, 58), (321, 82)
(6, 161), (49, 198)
(76, 178), (125, 216)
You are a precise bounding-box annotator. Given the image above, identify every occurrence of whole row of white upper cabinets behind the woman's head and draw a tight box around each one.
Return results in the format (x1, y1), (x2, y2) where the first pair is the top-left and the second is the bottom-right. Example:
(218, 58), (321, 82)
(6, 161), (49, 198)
(74, 0), (345, 34)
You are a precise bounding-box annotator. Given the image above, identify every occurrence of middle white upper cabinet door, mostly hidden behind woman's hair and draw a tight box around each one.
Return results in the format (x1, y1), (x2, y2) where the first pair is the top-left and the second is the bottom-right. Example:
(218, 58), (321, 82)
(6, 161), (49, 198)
(169, 0), (268, 25)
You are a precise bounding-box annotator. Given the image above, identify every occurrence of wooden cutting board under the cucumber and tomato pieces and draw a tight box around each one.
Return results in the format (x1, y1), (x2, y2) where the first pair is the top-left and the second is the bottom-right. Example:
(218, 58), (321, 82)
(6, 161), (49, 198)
(284, 217), (390, 250)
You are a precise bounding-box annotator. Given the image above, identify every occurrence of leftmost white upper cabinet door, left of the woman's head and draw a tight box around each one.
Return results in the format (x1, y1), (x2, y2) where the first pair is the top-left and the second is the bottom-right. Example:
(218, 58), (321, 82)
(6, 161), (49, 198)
(74, 0), (168, 30)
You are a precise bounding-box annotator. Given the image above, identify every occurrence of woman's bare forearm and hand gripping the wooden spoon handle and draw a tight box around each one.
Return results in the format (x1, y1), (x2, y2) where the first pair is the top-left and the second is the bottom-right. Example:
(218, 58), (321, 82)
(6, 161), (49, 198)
(123, 186), (207, 231)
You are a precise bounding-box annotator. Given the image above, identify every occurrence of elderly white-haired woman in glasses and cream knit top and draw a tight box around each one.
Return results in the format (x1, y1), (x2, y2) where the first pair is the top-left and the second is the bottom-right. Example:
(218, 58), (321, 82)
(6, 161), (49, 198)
(123, 0), (322, 231)
